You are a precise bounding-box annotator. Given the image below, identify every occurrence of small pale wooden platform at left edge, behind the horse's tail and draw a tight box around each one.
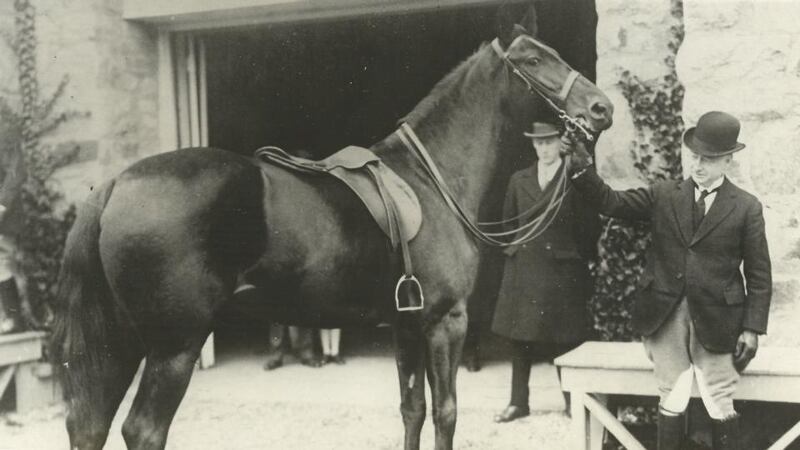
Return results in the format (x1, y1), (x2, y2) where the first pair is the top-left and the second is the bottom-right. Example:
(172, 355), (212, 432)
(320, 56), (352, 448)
(0, 331), (60, 413)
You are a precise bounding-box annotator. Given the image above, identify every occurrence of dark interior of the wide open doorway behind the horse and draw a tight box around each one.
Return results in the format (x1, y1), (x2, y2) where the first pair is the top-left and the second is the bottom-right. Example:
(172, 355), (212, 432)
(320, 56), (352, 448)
(194, 0), (596, 364)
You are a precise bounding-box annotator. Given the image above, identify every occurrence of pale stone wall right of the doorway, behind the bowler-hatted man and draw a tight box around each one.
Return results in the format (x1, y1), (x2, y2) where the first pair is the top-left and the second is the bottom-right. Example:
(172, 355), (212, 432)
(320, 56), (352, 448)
(597, 0), (800, 345)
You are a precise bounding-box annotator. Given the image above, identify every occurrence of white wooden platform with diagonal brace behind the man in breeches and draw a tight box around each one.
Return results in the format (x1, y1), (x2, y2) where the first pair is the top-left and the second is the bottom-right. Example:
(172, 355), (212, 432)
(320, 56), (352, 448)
(555, 342), (800, 450)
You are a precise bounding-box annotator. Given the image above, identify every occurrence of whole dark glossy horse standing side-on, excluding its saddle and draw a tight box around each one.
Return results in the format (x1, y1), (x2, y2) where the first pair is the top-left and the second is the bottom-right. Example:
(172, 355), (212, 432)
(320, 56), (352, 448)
(52, 11), (613, 450)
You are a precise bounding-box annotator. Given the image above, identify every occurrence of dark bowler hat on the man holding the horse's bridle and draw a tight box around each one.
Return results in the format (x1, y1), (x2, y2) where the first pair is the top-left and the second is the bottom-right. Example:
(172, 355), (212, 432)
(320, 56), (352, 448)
(683, 111), (744, 158)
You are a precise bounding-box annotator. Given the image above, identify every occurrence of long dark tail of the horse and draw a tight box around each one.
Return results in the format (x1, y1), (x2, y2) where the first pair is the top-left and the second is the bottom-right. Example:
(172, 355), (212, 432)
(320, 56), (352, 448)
(51, 180), (116, 400)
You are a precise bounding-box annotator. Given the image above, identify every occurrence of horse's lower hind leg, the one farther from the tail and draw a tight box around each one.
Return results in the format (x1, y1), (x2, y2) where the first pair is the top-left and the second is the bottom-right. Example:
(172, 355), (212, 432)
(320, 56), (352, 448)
(122, 333), (208, 449)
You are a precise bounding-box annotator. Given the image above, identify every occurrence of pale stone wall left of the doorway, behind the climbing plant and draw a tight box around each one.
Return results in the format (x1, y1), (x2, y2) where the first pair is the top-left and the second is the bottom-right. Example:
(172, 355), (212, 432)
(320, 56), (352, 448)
(0, 0), (159, 201)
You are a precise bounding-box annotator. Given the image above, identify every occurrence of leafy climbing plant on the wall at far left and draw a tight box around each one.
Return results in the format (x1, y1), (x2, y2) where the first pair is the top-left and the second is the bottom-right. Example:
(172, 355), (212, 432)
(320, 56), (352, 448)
(0, 0), (85, 328)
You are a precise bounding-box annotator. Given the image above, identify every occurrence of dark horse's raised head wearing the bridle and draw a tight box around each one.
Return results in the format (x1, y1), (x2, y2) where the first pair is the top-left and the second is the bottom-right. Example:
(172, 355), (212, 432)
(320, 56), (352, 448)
(492, 14), (614, 134)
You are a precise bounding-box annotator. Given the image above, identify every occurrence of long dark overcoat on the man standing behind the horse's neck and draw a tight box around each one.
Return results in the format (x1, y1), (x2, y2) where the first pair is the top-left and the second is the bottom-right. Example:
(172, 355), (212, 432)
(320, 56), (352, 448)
(492, 164), (599, 343)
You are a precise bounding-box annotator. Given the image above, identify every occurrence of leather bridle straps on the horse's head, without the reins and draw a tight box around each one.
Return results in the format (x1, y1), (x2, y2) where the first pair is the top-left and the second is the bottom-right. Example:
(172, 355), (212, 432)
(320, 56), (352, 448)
(492, 35), (594, 142)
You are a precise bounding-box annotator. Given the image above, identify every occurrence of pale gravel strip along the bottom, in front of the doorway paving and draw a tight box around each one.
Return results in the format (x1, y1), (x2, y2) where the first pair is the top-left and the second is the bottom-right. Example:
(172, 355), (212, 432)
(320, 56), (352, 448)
(0, 400), (568, 450)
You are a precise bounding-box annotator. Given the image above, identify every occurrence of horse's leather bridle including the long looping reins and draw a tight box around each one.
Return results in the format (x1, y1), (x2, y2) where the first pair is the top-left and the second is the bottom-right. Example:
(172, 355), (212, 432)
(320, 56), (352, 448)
(395, 35), (594, 247)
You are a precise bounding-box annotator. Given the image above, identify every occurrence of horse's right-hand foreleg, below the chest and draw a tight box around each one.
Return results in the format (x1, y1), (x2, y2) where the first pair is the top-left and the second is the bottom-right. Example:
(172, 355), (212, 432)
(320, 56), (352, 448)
(426, 301), (467, 450)
